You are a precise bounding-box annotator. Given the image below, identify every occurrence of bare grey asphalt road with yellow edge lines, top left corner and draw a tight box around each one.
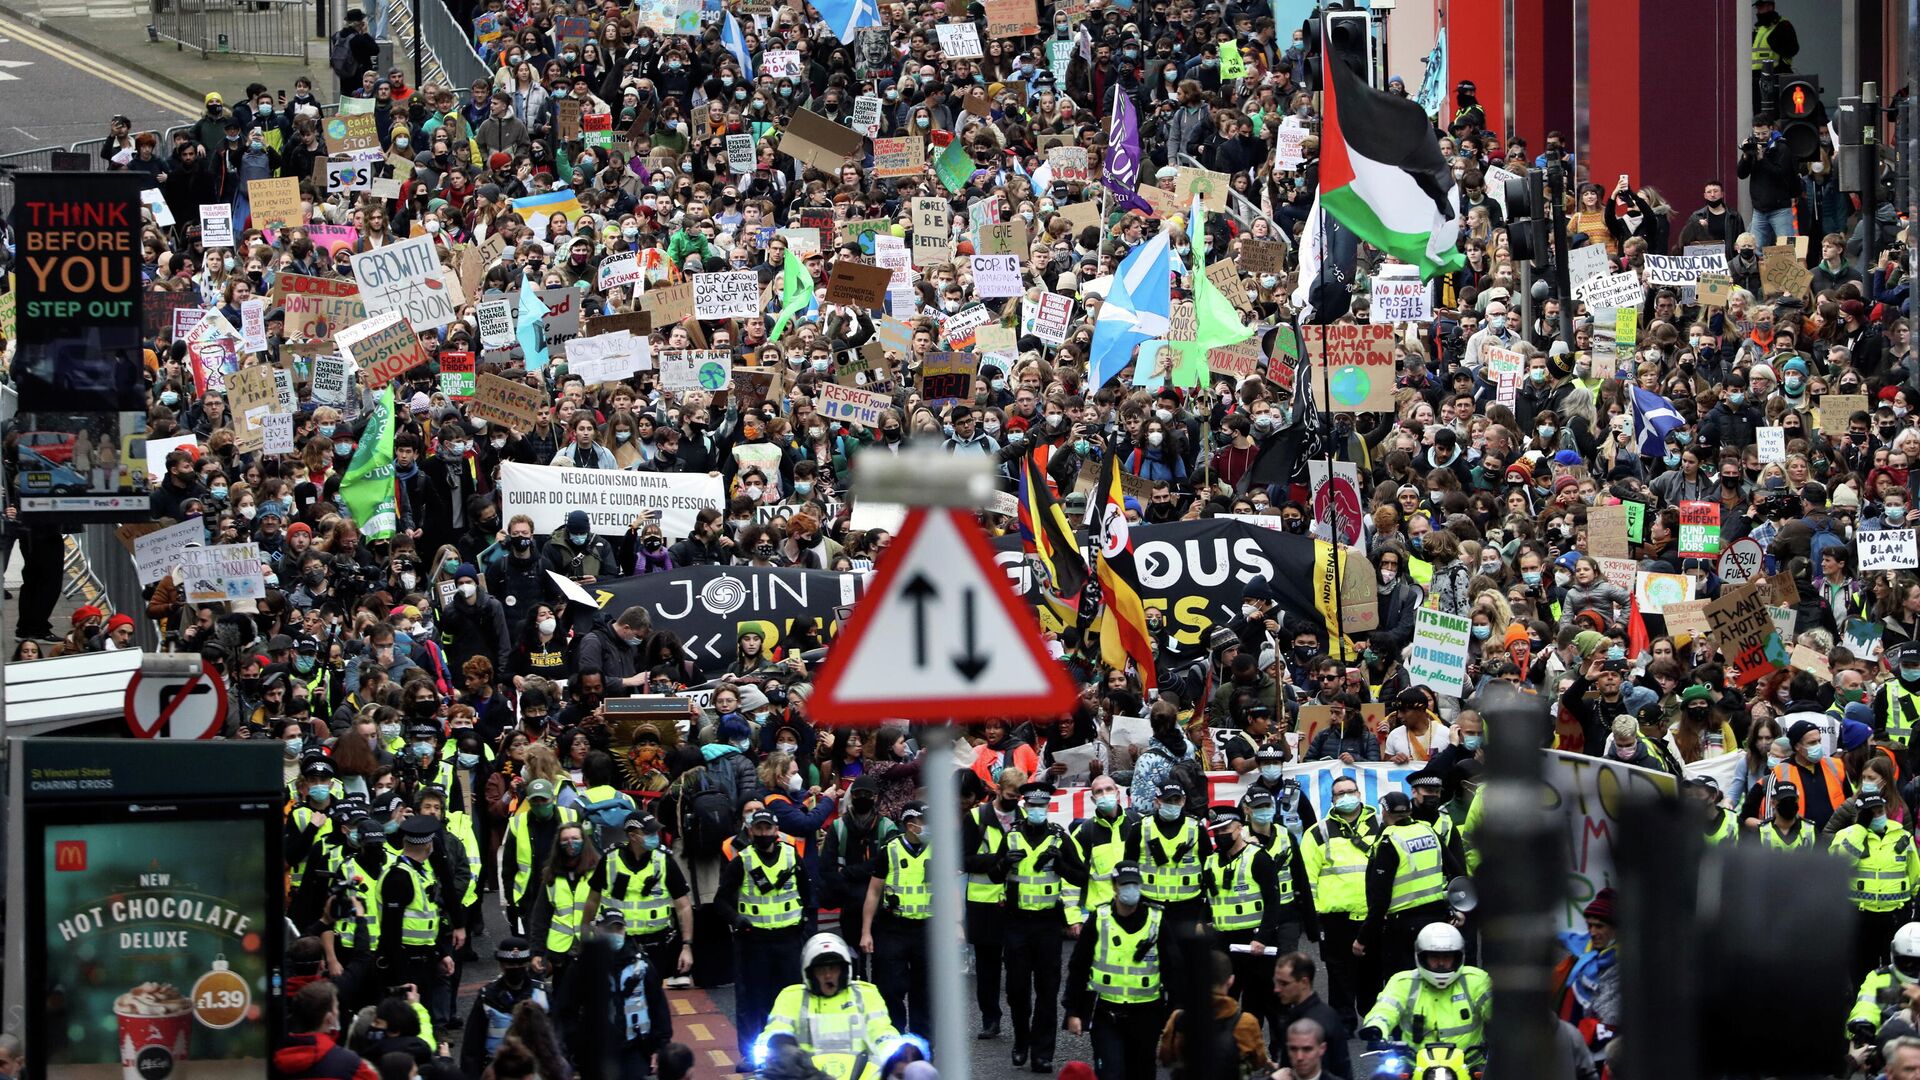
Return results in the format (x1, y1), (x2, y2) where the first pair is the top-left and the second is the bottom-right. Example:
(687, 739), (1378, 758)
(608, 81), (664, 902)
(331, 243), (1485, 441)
(0, 17), (200, 154)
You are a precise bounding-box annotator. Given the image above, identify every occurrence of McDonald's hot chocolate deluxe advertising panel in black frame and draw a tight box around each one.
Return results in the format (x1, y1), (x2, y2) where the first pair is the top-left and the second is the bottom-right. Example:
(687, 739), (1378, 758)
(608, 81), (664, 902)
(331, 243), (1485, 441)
(8, 738), (286, 1080)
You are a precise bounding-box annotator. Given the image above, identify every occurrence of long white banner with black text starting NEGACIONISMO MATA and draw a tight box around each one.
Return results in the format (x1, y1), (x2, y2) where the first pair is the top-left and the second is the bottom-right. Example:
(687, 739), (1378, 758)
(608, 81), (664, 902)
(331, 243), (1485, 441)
(499, 461), (726, 536)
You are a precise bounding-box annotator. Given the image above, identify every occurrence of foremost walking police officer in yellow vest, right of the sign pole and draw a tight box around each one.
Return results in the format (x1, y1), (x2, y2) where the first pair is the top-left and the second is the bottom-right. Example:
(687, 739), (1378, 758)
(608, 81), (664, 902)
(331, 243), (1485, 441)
(1062, 859), (1165, 1080)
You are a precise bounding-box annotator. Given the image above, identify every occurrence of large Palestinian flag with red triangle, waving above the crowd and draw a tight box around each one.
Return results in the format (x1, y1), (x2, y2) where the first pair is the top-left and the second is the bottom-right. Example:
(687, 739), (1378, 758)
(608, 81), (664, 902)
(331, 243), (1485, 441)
(1319, 21), (1467, 279)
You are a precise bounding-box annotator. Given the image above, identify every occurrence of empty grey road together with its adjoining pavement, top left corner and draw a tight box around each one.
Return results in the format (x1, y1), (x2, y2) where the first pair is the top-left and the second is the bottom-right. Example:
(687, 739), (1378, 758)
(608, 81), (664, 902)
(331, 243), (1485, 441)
(0, 0), (338, 154)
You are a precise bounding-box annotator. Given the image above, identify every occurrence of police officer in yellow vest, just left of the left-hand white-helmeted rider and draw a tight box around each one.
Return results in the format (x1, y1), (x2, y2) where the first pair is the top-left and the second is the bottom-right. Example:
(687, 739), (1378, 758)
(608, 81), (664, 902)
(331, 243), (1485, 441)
(714, 809), (814, 1059)
